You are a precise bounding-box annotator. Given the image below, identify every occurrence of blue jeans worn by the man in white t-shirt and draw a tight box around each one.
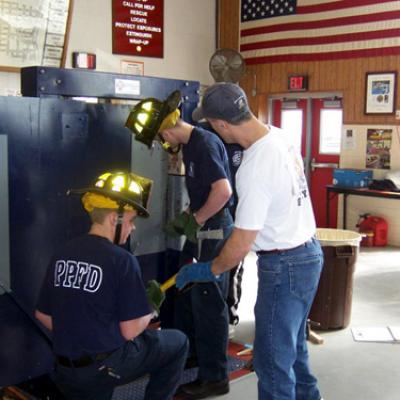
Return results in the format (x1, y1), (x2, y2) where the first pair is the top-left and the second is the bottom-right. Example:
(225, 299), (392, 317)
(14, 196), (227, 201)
(254, 239), (323, 400)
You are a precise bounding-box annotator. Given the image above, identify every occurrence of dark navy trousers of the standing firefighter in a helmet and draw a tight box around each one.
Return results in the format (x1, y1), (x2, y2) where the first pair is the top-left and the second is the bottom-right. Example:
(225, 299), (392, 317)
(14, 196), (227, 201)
(174, 210), (233, 380)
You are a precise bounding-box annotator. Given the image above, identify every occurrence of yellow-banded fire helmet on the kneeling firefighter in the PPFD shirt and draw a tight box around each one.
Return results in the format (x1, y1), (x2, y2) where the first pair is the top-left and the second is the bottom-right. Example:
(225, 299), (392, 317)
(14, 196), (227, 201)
(67, 171), (153, 217)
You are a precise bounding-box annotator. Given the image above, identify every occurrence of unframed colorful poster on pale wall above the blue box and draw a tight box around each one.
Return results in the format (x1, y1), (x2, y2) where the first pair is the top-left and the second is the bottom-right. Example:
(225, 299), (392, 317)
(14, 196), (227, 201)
(365, 129), (392, 169)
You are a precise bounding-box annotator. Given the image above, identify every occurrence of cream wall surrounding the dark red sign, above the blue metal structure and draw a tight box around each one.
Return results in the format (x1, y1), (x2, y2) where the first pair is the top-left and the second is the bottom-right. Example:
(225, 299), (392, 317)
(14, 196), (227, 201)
(0, 0), (216, 95)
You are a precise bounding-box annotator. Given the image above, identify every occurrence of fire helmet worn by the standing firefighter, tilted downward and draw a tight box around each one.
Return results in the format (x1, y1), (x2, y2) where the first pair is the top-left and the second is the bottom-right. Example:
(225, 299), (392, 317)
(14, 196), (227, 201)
(125, 90), (182, 152)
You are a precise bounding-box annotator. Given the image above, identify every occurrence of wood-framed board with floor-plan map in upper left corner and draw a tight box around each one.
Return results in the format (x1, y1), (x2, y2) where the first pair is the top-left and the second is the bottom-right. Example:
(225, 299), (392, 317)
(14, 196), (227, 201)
(0, 0), (73, 72)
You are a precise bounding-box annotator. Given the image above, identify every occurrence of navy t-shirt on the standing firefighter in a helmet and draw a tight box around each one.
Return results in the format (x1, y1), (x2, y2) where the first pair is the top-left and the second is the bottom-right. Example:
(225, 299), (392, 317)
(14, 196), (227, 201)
(182, 127), (232, 212)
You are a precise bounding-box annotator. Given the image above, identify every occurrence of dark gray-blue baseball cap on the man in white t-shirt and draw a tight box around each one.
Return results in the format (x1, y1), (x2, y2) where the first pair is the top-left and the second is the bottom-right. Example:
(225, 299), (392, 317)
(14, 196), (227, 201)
(192, 82), (250, 122)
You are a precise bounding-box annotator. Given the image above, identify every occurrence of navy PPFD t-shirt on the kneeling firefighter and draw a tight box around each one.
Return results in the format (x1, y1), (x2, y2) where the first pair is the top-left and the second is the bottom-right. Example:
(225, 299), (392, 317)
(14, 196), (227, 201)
(37, 235), (152, 359)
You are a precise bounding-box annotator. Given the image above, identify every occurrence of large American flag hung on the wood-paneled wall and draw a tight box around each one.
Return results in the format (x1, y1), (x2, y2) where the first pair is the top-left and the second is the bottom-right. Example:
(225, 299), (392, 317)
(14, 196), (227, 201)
(240, 0), (400, 65)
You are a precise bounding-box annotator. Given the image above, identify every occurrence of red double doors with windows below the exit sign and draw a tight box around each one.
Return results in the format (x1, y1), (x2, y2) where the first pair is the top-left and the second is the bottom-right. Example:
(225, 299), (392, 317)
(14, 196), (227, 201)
(272, 98), (342, 228)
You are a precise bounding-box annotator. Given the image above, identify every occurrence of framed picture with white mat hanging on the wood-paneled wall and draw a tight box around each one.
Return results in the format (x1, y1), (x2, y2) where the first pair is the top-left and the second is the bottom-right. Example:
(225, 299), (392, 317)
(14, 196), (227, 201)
(365, 71), (397, 114)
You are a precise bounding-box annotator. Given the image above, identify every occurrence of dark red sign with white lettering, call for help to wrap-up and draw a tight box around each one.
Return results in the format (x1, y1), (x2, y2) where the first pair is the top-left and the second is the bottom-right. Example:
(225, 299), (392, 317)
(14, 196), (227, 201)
(112, 0), (164, 58)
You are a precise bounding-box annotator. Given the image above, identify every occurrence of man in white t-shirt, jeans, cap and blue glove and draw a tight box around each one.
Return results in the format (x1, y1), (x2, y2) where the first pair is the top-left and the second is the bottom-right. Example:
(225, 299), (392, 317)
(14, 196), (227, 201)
(177, 83), (323, 400)
